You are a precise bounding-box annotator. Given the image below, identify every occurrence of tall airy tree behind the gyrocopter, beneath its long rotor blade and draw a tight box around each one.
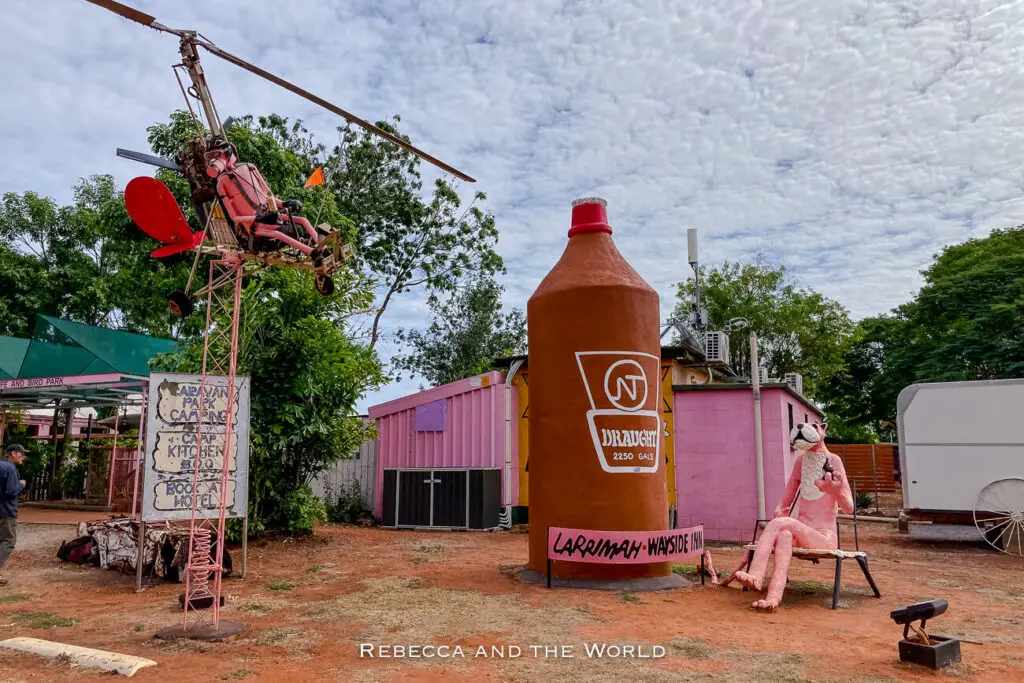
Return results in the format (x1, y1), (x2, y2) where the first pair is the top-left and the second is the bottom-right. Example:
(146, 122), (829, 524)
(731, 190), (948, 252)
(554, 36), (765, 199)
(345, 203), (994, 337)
(148, 112), (504, 347)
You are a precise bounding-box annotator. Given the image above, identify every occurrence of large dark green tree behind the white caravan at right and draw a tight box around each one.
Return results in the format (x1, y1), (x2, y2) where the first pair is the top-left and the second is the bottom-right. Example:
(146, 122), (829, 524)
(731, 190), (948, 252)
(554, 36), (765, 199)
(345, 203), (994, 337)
(822, 226), (1024, 438)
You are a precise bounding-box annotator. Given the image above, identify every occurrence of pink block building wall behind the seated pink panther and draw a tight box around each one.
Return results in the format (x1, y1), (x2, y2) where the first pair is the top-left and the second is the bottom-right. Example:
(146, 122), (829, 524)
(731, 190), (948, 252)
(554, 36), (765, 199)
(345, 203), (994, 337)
(674, 387), (821, 541)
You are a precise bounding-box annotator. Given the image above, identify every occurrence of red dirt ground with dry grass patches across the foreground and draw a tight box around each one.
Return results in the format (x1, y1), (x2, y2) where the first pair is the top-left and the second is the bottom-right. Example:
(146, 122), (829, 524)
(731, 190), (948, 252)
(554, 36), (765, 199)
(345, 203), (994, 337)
(0, 512), (1024, 683)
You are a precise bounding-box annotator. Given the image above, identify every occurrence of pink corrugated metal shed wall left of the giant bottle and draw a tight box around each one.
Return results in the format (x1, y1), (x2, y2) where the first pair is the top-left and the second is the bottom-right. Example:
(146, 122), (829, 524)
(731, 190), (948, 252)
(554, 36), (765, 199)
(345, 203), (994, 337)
(369, 372), (519, 519)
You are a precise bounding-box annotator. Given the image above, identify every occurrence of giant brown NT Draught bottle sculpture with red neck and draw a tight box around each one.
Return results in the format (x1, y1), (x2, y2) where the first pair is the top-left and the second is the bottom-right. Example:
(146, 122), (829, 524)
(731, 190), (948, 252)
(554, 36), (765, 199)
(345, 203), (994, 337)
(526, 198), (672, 580)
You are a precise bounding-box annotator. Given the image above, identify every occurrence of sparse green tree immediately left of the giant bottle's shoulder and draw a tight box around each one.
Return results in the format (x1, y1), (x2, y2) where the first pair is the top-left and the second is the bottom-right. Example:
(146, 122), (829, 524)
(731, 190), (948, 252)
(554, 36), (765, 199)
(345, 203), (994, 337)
(391, 276), (526, 386)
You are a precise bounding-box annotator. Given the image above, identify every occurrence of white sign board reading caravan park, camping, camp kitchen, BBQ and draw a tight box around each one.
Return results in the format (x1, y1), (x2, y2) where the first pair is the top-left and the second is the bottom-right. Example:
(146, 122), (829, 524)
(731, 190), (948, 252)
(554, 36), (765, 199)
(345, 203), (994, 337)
(142, 373), (249, 521)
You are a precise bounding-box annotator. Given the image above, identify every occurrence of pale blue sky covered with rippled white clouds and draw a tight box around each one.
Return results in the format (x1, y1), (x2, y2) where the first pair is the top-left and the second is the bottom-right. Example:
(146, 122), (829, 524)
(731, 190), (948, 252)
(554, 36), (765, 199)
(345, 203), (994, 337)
(6, 0), (1024, 408)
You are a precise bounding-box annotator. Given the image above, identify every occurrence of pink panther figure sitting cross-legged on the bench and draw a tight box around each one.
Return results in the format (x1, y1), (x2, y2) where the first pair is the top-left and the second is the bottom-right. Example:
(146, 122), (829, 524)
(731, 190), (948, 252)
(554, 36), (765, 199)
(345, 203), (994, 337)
(721, 424), (854, 610)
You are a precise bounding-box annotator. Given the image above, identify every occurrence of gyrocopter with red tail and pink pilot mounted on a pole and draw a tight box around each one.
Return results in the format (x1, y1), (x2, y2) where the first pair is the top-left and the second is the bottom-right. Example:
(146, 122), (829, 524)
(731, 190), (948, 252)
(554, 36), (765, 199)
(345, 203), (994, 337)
(88, 0), (475, 317)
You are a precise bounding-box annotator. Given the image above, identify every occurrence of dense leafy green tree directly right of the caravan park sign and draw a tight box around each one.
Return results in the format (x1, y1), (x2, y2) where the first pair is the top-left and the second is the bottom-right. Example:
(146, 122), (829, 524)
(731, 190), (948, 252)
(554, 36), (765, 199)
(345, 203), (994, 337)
(155, 268), (386, 530)
